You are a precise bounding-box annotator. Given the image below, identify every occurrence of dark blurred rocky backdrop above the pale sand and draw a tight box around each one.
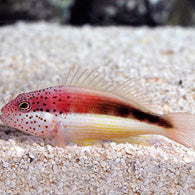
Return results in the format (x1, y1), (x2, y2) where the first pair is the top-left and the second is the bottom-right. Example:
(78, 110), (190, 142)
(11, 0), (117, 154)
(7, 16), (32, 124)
(0, 0), (195, 27)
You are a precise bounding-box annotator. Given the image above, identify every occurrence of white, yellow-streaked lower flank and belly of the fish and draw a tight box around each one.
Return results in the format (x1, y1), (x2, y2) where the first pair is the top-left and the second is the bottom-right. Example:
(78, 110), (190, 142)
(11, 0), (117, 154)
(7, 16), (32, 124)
(58, 114), (165, 142)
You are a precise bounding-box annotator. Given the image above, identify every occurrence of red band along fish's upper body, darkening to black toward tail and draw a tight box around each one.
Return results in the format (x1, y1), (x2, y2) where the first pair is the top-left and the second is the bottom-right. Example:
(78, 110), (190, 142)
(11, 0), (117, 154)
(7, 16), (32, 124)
(24, 86), (173, 128)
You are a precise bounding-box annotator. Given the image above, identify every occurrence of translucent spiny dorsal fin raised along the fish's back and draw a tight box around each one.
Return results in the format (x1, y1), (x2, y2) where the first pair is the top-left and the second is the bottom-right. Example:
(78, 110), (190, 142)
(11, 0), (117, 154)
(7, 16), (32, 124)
(64, 66), (157, 112)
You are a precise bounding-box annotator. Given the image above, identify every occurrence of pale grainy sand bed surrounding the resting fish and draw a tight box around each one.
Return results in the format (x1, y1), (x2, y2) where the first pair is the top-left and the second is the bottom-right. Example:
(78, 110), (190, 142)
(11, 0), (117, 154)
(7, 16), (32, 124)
(0, 23), (195, 195)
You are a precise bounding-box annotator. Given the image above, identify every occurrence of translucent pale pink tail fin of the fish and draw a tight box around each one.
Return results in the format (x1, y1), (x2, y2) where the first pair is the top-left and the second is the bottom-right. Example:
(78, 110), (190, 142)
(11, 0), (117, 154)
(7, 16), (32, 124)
(166, 113), (195, 148)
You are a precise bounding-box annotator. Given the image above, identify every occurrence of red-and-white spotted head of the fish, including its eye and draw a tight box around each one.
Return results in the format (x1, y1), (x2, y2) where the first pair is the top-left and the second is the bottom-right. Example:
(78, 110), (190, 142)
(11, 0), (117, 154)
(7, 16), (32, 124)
(0, 90), (54, 136)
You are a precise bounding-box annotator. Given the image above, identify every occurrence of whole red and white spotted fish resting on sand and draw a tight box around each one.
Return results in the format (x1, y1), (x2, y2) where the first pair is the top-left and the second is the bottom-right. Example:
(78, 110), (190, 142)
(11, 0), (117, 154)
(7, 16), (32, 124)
(0, 67), (195, 148)
